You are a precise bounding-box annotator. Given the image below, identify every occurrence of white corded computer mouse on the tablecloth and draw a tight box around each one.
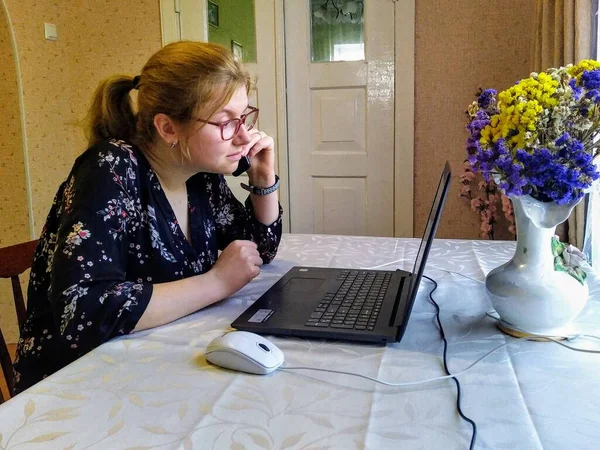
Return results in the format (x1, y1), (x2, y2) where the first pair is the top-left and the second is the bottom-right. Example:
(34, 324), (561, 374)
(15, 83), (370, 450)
(205, 331), (284, 375)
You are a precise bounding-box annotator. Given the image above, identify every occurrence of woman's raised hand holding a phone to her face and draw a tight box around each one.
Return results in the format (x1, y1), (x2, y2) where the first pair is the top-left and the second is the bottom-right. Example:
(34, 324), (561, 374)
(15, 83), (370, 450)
(246, 128), (275, 187)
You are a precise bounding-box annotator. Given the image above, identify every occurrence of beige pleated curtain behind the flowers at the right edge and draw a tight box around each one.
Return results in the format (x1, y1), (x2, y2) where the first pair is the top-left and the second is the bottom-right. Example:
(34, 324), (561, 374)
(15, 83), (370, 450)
(532, 0), (593, 249)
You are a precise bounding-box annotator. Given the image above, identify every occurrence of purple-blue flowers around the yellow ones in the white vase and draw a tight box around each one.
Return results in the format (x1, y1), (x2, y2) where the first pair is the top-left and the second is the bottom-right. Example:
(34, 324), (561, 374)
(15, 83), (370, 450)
(466, 78), (600, 204)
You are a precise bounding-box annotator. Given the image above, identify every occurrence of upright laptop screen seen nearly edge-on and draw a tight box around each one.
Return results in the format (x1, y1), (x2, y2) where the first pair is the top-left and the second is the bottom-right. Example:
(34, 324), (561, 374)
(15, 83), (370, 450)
(394, 161), (451, 327)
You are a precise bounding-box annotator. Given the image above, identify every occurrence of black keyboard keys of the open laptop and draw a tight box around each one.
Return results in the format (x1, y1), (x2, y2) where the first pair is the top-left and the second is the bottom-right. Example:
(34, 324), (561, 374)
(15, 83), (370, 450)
(305, 270), (392, 331)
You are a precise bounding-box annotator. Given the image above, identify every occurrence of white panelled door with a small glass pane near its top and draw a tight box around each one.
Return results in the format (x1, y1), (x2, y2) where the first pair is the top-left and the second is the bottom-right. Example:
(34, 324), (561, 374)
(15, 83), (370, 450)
(285, 0), (395, 236)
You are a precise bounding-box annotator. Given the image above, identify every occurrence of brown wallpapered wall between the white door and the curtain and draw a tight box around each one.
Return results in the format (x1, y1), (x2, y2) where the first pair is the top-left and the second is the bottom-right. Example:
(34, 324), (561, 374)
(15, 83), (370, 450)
(414, 0), (534, 239)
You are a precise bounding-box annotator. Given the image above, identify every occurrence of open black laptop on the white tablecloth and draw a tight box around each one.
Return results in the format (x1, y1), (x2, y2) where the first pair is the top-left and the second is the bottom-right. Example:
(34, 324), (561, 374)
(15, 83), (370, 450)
(231, 162), (450, 343)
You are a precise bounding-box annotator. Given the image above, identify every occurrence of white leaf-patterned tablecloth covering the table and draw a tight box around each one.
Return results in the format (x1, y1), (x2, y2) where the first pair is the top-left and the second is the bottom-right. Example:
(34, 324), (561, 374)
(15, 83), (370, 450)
(0, 234), (600, 450)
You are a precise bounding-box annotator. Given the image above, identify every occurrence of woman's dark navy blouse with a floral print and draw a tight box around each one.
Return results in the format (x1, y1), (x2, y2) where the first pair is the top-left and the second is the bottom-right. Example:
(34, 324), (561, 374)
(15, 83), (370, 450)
(14, 139), (282, 392)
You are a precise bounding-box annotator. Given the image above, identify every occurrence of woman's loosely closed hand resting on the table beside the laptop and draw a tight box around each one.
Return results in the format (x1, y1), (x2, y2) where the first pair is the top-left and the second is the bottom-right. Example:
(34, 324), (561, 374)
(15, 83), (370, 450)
(210, 241), (263, 298)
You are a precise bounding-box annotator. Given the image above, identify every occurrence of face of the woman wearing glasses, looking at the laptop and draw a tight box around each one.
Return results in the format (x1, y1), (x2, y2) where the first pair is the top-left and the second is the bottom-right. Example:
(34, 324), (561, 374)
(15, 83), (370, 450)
(187, 87), (254, 174)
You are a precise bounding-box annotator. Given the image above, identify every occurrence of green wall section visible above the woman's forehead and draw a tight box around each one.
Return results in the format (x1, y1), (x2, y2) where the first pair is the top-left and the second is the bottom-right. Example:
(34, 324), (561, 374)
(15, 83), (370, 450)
(208, 0), (256, 62)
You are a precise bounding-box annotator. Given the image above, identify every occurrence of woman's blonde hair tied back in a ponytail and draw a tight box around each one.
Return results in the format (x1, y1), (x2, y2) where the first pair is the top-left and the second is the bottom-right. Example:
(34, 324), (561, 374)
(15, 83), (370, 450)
(86, 41), (252, 150)
